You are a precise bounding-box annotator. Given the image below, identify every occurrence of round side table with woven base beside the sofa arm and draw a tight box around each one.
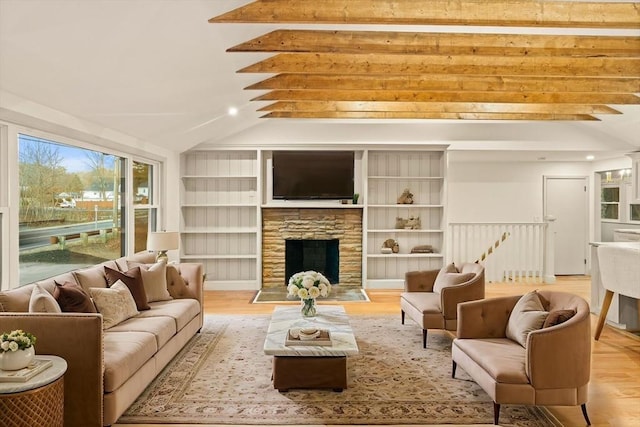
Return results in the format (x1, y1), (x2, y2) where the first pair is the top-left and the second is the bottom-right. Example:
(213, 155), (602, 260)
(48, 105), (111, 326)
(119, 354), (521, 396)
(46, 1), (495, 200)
(0, 355), (67, 427)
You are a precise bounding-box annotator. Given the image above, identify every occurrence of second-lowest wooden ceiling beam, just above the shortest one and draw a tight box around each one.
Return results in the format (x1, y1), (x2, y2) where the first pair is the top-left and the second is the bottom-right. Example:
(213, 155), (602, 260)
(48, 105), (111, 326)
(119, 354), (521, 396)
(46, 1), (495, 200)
(258, 101), (622, 114)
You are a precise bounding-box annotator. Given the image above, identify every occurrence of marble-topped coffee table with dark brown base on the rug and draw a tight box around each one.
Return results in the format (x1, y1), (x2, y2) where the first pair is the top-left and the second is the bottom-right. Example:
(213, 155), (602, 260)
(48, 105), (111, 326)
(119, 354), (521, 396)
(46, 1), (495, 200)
(264, 305), (358, 392)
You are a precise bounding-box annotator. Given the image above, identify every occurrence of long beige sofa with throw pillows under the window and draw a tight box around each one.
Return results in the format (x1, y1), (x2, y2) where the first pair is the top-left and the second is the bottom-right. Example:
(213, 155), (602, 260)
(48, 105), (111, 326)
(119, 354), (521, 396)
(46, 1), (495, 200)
(0, 253), (203, 427)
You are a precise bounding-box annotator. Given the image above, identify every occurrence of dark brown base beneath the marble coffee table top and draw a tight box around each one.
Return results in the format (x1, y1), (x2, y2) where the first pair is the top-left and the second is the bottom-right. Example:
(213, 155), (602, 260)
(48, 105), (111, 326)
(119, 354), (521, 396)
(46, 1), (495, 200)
(273, 356), (347, 392)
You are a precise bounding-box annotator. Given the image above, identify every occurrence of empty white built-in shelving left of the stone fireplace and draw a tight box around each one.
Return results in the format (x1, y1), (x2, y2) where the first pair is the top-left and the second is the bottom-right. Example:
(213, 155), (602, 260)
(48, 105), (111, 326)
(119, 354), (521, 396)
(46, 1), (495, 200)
(180, 150), (261, 289)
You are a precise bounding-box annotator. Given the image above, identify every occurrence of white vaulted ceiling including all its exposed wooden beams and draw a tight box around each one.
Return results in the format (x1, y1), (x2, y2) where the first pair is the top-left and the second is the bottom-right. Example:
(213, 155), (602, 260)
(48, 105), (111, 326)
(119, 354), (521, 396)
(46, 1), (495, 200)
(0, 0), (640, 158)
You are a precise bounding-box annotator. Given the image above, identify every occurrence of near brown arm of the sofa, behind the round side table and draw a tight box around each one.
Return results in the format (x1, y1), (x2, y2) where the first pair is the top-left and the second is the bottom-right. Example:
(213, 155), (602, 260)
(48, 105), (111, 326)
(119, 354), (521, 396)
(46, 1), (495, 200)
(0, 313), (104, 427)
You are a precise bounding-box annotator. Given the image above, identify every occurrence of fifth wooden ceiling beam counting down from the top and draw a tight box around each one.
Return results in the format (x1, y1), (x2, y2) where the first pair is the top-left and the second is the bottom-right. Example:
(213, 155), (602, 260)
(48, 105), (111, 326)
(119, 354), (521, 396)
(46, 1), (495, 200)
(252, 90), (640, 105)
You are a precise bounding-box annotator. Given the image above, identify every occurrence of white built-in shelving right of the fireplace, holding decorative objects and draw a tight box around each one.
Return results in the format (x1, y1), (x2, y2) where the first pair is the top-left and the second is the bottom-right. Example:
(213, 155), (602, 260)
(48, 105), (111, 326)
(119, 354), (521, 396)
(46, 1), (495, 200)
(364, 148), (445, 288)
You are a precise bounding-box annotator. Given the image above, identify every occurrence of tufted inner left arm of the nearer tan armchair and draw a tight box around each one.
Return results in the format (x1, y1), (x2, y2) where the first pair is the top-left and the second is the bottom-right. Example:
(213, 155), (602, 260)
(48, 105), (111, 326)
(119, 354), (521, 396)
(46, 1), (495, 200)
(456, 295), (520, 338)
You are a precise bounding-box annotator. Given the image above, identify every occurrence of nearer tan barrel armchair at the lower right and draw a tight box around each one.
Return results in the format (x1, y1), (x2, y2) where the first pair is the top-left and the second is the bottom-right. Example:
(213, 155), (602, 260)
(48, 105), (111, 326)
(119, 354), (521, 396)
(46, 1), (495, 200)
(451, 291), (591, 425)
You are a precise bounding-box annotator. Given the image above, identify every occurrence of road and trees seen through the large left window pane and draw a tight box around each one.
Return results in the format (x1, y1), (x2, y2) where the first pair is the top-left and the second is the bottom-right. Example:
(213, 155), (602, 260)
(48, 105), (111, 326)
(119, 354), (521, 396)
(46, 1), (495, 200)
(18, 134), (126, 285)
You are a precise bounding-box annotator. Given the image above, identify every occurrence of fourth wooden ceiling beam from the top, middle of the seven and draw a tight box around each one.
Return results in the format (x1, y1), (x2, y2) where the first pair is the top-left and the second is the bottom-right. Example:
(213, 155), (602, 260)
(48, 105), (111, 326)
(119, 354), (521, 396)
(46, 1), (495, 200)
(245, 74), (640, 93)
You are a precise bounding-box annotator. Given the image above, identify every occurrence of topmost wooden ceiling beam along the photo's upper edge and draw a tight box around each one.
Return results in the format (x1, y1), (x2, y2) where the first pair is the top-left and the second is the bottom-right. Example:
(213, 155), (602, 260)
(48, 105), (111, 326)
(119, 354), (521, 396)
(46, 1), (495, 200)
(209, 0), (640, 28)
